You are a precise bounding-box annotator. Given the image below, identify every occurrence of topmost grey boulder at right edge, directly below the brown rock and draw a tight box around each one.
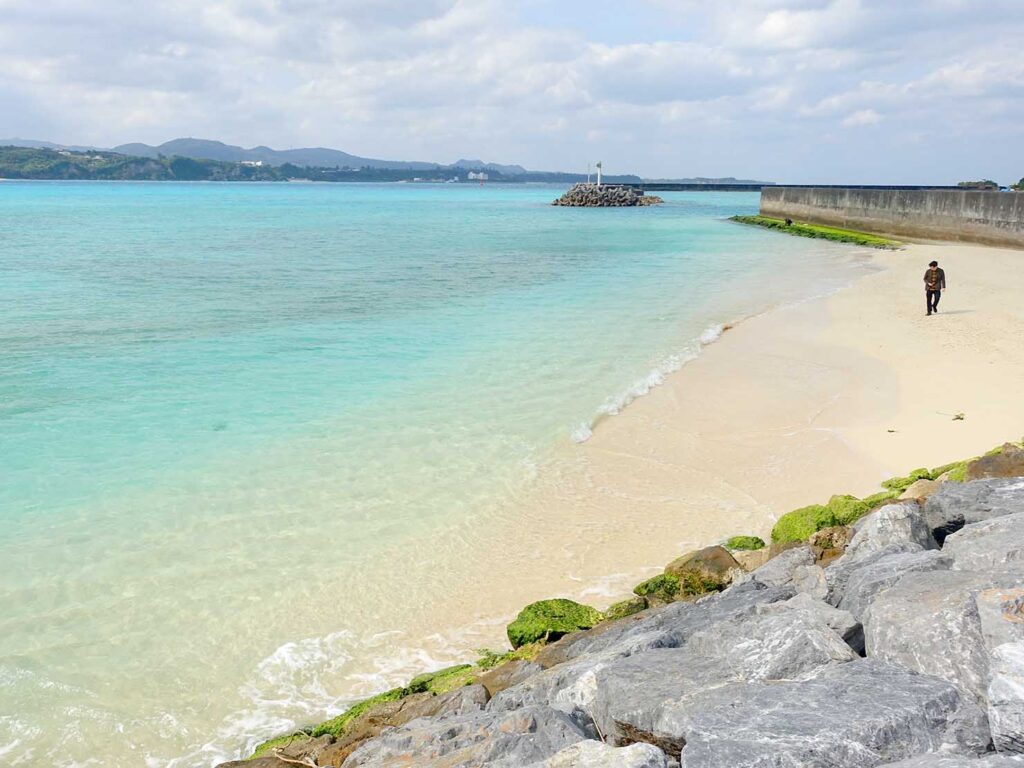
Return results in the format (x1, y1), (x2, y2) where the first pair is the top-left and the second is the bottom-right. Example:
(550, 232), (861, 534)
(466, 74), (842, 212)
(925, 477), (1024, 544)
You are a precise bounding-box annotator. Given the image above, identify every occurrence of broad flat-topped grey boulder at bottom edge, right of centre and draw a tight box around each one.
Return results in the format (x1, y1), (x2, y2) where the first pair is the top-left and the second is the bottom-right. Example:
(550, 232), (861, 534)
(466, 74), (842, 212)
(656, 659), (989, 768)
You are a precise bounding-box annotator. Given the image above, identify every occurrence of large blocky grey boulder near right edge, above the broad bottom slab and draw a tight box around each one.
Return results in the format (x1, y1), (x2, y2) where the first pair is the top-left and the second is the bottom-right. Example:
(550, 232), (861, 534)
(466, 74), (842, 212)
(864, 570), (1019, 701)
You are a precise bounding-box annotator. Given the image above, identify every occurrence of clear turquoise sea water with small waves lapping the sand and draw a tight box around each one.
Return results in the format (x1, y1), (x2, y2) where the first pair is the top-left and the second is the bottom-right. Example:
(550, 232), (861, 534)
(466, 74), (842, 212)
(0, 181), (857, 768)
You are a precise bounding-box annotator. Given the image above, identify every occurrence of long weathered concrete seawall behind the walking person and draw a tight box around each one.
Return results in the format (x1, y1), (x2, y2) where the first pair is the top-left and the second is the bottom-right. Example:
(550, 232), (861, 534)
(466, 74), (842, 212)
(761, 186), (1024, 248)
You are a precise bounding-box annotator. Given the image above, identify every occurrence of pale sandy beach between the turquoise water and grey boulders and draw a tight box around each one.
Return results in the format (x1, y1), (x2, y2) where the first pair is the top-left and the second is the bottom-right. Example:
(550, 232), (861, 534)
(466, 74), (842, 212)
(214, 236), (1024, 765)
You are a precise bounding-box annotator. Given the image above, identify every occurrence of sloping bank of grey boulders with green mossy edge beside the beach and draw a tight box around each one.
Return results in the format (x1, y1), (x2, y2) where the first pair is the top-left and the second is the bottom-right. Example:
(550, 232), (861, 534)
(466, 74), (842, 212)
(221, 443), (1024, 768)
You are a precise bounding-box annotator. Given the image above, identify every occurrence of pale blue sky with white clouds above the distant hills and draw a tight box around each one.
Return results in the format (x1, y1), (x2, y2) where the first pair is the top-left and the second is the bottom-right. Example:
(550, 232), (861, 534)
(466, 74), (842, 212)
(0, 0), (1024, 183)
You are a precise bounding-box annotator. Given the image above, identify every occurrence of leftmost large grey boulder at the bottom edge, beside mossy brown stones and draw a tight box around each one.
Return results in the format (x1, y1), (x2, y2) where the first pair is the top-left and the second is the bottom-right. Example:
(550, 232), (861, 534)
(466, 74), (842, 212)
(343, 707), (587, 768)
